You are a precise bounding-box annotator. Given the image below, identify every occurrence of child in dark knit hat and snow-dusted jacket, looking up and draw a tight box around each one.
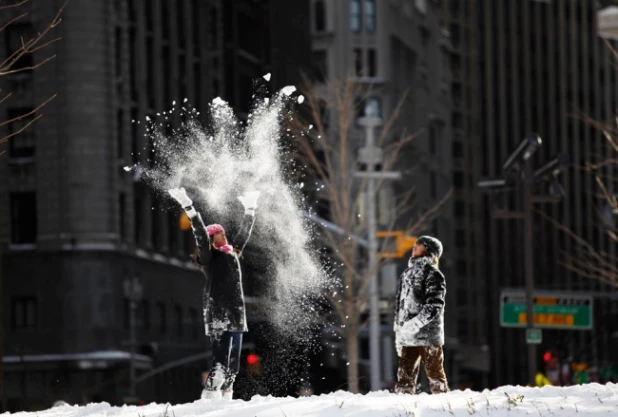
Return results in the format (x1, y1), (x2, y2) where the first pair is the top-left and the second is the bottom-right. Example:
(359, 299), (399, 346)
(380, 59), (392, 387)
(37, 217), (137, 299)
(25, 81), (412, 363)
(394, 236), (448, 394)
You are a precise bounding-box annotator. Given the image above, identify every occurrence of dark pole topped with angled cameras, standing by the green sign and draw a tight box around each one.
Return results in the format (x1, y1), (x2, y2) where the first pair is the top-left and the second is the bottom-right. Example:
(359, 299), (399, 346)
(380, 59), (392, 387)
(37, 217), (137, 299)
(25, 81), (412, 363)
(478, 134), (568, 386)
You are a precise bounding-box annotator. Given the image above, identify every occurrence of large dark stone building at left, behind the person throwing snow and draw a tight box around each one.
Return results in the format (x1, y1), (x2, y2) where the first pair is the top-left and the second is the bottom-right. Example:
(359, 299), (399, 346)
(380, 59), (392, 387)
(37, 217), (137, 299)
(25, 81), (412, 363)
(0, 0), (310, 411)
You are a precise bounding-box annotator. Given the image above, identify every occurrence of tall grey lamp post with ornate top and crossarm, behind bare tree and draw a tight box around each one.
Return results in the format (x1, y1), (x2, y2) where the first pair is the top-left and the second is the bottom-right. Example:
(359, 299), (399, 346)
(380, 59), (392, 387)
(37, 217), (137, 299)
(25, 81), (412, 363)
(355, 102), (401, 391)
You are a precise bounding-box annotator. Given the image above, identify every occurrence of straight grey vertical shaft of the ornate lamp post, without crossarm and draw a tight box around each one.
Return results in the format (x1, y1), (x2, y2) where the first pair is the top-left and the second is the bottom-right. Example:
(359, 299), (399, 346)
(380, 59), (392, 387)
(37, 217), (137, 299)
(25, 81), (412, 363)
(366, 125), (381, 391)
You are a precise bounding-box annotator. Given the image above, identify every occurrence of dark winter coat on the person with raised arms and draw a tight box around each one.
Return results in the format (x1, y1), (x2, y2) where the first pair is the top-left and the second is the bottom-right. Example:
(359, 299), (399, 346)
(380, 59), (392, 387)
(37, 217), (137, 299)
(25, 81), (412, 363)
(190, 213), (255, 337)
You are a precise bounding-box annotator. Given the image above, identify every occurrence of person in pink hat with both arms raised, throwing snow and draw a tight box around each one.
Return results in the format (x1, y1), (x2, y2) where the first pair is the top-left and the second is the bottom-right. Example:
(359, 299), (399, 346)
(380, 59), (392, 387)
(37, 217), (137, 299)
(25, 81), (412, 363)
(168, 188), (259, 400)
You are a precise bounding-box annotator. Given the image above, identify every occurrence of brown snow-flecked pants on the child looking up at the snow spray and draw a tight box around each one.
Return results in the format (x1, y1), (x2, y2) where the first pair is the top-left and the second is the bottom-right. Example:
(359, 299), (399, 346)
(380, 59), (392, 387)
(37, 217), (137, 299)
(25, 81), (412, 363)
(395, 345), (448, 394)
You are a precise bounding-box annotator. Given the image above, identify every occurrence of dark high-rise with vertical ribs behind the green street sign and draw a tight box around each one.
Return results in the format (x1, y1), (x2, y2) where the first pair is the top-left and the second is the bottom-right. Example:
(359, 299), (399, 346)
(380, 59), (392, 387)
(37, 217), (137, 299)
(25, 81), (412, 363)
(472, 0), (618, 385)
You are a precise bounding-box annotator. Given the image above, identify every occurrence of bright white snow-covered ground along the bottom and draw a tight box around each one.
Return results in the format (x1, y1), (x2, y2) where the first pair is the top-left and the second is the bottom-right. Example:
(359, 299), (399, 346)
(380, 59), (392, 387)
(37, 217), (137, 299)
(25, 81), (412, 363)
(3, 384), (618, 417)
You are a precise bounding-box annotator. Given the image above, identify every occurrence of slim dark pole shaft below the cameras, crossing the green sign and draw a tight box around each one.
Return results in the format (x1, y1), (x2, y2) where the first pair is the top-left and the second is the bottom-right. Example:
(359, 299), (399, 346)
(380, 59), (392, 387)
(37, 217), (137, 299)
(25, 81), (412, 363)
(523, 180), (536, 386)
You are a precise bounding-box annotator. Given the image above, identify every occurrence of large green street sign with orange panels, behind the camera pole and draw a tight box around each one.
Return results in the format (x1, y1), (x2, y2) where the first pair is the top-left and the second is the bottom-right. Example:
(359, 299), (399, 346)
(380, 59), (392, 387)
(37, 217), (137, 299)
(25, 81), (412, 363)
(500, 291), (593, 330)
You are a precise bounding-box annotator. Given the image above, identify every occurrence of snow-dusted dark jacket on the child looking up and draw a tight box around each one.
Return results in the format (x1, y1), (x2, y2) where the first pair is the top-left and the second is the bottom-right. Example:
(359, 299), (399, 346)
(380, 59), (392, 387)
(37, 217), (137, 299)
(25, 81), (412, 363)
(394, 257), (446, 350)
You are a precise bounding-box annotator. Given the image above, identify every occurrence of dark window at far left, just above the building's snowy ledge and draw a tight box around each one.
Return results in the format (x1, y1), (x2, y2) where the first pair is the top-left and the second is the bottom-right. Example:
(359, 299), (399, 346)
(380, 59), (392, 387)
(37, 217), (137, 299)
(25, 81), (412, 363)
(9, 191), (37, 245)
